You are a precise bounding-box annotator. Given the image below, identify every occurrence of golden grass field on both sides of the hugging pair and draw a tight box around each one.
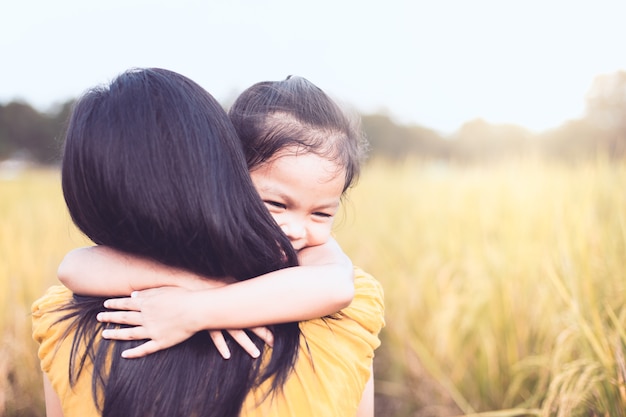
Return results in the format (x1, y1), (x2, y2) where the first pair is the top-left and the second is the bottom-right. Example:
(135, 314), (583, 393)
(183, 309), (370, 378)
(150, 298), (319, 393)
(0, 160), (626, 417)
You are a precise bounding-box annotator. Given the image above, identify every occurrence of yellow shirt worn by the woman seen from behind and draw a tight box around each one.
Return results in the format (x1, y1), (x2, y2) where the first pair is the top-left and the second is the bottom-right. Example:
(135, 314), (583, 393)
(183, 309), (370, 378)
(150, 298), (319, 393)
(32, 268), (384, 417)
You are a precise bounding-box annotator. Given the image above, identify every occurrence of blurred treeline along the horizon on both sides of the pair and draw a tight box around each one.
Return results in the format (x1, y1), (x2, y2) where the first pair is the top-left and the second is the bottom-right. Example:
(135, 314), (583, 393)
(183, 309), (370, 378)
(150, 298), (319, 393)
(0, 71), (626, 164)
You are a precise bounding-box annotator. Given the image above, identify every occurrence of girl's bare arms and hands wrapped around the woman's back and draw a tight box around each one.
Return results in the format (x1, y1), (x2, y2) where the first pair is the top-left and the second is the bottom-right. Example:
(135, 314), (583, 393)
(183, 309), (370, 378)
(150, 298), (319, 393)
(60, 240), (354, 358)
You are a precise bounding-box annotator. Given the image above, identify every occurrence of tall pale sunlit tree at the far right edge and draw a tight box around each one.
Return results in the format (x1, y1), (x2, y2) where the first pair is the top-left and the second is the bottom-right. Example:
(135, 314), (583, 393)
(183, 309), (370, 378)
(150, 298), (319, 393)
(586, 71), (626, 157)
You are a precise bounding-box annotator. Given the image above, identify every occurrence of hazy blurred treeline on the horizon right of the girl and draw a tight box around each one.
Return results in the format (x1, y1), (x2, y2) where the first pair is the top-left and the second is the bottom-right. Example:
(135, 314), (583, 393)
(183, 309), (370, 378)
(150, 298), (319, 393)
(356, 71), (626, 163)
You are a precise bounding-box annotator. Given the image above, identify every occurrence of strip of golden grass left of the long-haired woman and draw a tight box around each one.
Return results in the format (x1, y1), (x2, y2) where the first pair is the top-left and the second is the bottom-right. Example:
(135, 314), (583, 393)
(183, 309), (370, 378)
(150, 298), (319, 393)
(0, 170), (86, 417)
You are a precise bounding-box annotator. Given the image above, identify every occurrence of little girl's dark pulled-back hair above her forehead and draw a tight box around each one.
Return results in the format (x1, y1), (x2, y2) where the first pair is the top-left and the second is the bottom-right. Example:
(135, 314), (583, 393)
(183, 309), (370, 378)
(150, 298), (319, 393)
(228, 76), (367, 191)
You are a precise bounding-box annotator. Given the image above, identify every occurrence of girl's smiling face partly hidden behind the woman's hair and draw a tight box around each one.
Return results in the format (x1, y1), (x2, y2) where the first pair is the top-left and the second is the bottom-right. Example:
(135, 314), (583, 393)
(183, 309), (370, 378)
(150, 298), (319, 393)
(250, 153), (345, 250)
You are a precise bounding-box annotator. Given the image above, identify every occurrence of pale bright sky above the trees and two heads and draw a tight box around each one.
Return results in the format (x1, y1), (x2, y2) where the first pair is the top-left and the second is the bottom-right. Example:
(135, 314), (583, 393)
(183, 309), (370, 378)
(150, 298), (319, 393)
(0, 0), (626, 133)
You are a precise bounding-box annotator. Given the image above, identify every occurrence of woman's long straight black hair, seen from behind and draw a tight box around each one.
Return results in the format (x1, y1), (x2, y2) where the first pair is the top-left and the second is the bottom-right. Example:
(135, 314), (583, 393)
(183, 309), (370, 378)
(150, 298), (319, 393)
(62, 69), (300, 417)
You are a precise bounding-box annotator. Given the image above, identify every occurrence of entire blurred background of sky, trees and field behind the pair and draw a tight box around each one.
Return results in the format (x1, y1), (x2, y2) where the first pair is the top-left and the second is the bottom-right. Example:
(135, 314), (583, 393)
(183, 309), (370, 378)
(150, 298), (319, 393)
(0, 0), (626, 417)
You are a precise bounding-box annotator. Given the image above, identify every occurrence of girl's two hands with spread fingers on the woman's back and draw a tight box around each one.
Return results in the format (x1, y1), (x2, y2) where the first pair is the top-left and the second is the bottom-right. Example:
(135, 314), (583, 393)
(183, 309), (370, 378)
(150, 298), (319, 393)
(97, 287), (273, 359)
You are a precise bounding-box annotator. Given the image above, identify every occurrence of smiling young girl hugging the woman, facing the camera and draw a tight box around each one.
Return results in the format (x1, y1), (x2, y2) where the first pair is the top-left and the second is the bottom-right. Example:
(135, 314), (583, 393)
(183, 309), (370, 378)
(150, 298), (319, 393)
(59, 77), (383, 415)
